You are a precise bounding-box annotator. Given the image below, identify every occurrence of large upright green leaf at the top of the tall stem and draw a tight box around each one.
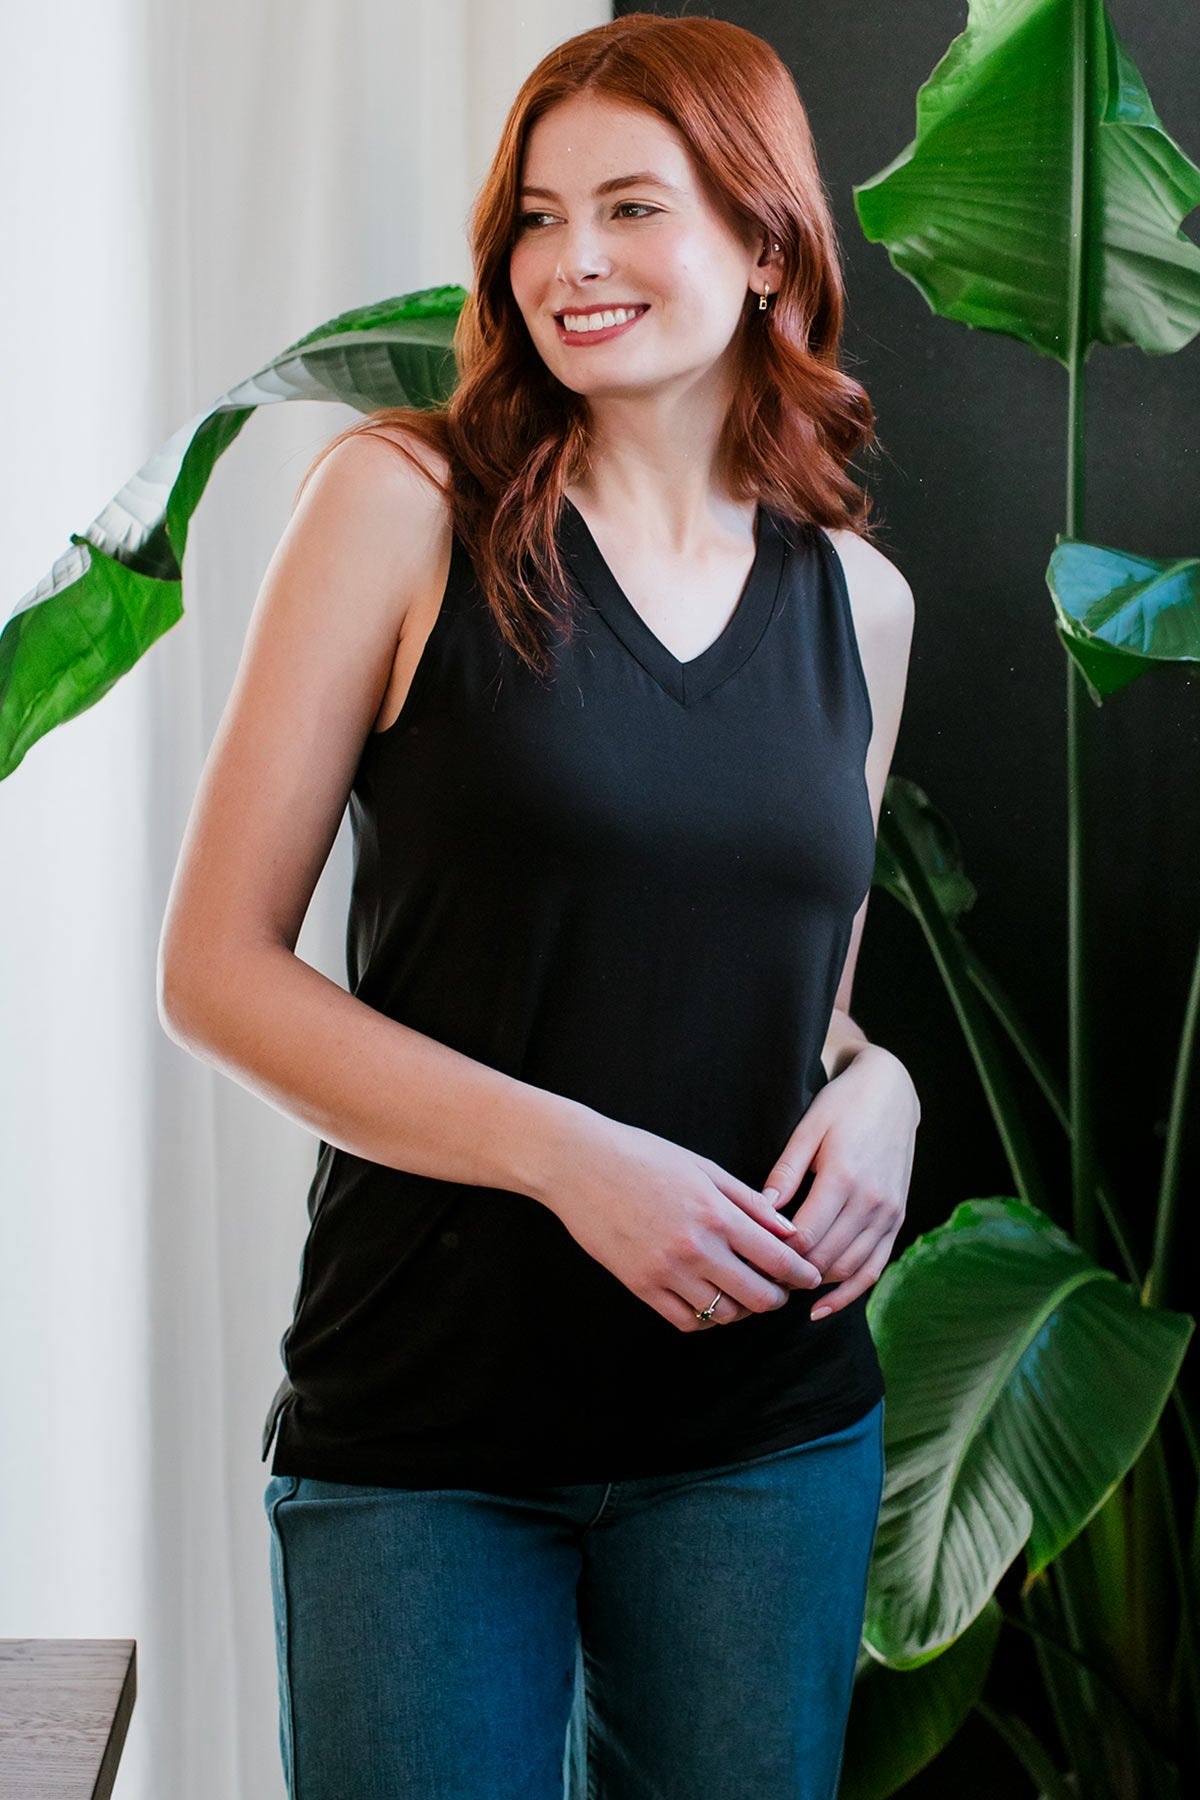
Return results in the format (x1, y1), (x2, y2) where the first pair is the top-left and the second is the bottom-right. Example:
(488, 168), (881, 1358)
(855, 0), (1200, 364)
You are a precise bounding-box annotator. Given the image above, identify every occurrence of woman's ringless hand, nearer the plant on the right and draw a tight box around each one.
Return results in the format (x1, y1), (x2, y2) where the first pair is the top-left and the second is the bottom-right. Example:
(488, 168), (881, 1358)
(763, 1044), (921, 1319)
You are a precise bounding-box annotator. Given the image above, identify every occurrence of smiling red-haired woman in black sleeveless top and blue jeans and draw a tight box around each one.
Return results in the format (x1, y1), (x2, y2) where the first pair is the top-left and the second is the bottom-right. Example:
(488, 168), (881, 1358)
(162, 14), (919, 1800)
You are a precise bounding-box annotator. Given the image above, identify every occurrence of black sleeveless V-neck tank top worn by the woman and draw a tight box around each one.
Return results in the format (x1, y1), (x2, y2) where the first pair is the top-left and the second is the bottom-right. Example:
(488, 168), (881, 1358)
(263, 502), (883, 1494)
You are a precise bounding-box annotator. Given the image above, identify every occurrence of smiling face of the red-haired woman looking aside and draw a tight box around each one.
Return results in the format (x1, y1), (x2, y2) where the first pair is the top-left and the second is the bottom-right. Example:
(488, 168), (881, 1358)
(509, 95), (777, 400)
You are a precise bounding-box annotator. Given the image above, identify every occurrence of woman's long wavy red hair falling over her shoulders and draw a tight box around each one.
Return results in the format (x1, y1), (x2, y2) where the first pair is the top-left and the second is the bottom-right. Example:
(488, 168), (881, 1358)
(293, 13), (874, 671)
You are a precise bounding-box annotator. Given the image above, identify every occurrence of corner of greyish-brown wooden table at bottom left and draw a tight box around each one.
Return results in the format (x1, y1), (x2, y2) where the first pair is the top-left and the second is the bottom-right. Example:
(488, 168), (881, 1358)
(0, 1638), (137, 1800)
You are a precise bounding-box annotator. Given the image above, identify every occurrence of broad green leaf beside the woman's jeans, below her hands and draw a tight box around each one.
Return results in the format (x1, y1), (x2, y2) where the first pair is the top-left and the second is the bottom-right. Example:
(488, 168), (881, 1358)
(864, 1199), (1193, 1669)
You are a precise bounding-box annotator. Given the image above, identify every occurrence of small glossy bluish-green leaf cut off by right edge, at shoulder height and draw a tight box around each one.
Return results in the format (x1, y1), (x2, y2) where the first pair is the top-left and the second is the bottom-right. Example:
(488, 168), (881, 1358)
(1045, 536), (1200, 700)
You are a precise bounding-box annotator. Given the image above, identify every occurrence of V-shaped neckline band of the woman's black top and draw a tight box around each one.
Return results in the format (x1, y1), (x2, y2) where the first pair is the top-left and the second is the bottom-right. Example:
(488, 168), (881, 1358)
(561, 495), (786, 706)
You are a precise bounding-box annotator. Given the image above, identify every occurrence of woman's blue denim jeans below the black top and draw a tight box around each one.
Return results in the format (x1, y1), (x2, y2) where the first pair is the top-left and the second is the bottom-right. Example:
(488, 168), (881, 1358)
(264, 1400), (885, 1800)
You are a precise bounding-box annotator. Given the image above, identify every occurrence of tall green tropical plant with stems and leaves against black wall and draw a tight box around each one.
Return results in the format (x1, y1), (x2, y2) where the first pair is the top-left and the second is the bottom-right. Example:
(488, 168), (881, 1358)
(840, 0), (1200, 1800)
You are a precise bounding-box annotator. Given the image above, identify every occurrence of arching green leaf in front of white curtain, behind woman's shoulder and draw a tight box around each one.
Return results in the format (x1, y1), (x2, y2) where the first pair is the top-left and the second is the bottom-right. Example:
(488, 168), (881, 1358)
(0, 288), (466, 779)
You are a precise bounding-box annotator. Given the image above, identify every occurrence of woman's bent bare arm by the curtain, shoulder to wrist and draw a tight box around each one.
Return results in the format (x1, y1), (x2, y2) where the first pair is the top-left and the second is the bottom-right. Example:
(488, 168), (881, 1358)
(158, 424), (587, 1192)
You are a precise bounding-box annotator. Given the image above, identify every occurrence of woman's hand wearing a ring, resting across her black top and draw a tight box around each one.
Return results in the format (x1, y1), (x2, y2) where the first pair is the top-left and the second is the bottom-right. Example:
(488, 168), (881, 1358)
(534, 1112), (822, 1332)
